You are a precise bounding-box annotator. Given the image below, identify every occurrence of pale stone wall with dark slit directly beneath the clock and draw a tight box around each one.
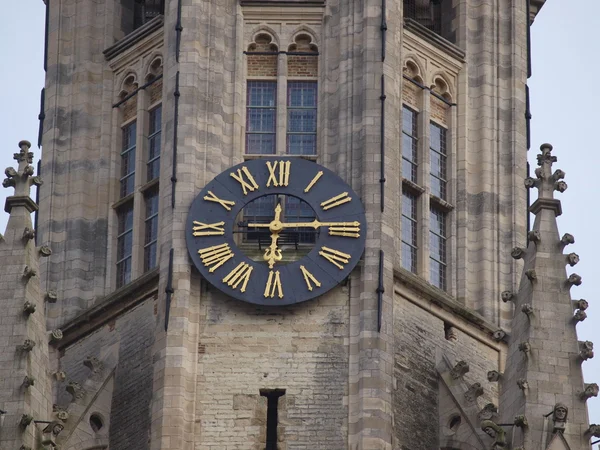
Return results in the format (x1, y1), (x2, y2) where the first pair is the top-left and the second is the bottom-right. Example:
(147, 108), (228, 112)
(196, 287), (349, 450)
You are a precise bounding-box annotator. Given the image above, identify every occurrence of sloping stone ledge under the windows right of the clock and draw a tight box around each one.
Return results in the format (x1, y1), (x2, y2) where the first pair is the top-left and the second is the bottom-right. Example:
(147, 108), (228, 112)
(394, 269), (508, 342)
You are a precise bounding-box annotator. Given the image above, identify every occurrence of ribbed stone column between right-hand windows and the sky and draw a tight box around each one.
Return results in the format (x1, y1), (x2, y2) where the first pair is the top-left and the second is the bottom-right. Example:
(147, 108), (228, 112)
(455, 0), (527, 326)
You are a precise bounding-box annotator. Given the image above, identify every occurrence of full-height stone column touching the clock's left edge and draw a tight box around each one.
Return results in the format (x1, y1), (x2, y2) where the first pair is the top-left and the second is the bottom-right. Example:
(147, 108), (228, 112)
(151, 0), (239, 450)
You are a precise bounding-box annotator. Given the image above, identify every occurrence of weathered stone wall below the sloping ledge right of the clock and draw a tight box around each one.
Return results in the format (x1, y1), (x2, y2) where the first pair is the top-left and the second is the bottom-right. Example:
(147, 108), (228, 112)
(393, 286), (499, 450)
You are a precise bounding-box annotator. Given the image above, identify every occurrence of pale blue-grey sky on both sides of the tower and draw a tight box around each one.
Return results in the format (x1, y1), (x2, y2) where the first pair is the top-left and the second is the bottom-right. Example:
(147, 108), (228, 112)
(0, 0), (600, 423)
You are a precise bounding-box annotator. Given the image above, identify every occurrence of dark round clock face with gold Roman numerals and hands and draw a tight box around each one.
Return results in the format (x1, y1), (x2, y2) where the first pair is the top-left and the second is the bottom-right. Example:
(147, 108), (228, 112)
(186, 158), (367, 305)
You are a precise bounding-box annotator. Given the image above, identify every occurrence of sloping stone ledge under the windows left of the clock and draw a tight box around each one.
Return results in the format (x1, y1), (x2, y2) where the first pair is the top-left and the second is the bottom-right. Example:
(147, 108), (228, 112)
(56, 267), (159, 350)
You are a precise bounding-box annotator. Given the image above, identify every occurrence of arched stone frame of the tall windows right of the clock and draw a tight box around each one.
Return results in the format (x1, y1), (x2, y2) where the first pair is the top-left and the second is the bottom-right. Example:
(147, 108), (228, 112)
(400, 55), (457, 294)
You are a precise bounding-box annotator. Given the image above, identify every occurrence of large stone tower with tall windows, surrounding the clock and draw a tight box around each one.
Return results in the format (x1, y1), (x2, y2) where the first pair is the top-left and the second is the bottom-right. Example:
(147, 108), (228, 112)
(0, 0), (584, 450)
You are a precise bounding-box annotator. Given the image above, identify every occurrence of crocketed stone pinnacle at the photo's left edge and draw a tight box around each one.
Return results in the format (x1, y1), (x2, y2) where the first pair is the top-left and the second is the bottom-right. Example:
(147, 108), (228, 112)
(0, 141), (52, 449)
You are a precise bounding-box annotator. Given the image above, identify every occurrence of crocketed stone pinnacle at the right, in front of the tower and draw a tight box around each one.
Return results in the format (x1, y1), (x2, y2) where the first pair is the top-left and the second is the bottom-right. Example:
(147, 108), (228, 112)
(494, 144), (598, 450)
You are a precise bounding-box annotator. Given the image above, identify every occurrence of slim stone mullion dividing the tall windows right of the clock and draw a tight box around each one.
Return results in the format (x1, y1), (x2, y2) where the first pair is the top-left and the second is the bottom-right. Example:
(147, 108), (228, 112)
(417, 89), (431, 281)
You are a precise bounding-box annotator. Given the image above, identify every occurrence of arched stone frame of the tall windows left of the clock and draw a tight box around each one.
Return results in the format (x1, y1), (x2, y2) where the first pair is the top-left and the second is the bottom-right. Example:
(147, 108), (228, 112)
(110, 53), (164, 289)
